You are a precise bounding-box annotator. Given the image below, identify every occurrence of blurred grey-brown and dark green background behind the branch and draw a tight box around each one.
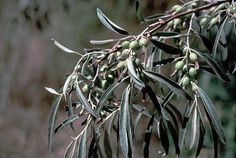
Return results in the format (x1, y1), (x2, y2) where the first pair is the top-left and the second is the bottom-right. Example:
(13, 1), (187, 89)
(0, 0), (236, 158)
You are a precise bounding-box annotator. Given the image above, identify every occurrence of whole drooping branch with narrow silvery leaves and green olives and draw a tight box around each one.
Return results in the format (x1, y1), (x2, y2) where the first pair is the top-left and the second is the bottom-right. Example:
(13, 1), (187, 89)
(46, 0), (236, 158)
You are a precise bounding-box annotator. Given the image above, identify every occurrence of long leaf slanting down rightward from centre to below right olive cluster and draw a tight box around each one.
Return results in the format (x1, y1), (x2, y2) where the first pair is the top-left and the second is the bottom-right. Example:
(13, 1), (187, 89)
(143, 71), (192, 100)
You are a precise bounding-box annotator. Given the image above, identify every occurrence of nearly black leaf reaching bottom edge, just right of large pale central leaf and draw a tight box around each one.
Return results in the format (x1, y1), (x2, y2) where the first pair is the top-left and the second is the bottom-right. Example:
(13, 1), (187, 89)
(143, 113), (155, 158)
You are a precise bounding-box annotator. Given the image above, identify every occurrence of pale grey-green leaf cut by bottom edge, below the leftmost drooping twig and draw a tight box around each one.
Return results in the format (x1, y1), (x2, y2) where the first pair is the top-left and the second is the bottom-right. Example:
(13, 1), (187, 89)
(78, 128), (87, 158)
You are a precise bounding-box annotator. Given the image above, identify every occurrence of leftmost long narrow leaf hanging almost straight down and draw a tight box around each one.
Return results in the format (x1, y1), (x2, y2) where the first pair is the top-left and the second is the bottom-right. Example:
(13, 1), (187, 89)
(48, 95), (62, 151)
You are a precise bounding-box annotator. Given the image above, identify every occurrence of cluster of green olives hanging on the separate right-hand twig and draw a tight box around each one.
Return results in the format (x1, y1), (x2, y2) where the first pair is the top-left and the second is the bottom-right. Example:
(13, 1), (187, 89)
(175, 47), (198, 91)
